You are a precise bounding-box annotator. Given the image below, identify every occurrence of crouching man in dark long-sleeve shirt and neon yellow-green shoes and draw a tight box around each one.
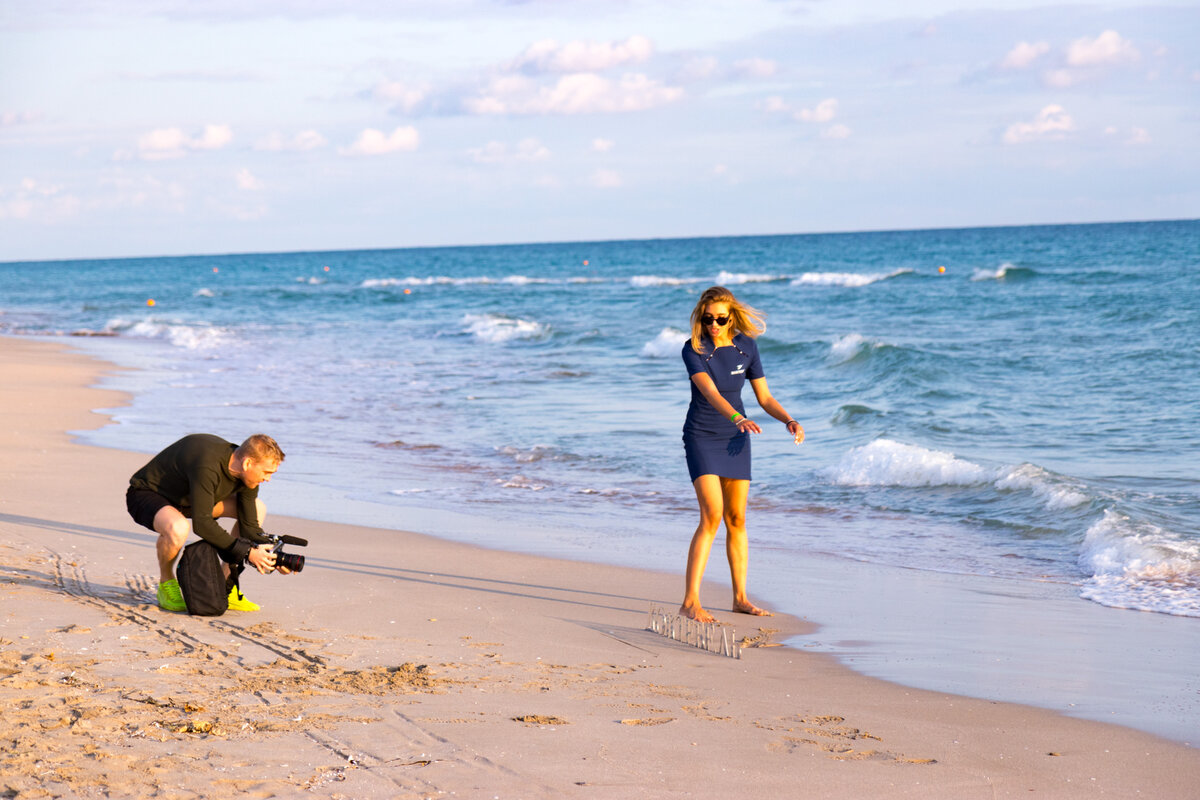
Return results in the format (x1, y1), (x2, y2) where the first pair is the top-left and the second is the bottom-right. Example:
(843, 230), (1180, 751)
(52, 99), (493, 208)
(125, 433), (288, 612)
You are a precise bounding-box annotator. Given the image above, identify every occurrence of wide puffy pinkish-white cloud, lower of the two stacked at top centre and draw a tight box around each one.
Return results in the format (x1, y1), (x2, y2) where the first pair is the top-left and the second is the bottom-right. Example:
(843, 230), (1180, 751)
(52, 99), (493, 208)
(463, 72), (683, 115)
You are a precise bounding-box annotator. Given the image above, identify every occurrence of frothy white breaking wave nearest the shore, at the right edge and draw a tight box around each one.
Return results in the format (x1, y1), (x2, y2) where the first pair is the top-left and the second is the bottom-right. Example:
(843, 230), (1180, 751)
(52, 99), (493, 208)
(1079, 510), (1200, 616)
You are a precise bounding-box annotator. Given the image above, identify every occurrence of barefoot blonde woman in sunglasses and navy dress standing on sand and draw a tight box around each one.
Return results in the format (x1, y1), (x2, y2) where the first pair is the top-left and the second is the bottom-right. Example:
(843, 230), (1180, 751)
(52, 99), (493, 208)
(679, 287), (804, 622)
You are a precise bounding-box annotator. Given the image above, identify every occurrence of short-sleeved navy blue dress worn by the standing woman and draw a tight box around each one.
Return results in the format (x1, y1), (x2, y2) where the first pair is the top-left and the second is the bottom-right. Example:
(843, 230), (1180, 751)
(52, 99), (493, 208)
(683, 333), (763, 481)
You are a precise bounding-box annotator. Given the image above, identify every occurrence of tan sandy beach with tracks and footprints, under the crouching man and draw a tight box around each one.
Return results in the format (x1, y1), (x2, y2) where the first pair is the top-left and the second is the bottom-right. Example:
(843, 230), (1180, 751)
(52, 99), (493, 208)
(0, 338), (1200, 799)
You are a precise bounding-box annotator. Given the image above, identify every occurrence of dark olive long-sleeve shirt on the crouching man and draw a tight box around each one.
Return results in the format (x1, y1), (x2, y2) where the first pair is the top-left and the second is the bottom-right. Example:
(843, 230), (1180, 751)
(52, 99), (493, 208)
(130, 433), (266, 551)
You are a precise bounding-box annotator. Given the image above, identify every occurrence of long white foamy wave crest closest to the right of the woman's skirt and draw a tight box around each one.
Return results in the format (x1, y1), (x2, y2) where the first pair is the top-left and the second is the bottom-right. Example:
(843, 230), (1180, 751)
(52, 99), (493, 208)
(830, 439), (995, 487)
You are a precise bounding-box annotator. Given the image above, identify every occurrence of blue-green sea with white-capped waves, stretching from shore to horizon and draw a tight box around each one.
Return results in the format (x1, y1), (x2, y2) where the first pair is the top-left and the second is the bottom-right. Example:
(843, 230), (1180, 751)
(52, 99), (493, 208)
(0, 221), (1200, 743)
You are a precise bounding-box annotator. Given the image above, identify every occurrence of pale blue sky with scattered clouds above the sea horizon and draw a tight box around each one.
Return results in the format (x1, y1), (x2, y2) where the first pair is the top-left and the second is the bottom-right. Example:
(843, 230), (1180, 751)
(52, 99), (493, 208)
(0, 0), (1200, 260)
